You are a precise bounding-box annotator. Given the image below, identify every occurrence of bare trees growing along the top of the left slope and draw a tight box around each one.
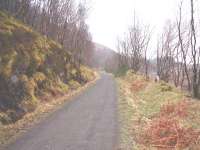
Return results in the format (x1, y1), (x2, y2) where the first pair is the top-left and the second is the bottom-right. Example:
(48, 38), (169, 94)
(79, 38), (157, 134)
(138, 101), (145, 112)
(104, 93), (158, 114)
(0, 0), (93, 66)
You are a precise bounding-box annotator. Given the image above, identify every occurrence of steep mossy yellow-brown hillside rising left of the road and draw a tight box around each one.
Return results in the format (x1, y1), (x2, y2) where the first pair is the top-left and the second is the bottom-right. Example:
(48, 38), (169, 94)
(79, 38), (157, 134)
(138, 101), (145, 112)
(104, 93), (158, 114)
(0, 12), (94, 124)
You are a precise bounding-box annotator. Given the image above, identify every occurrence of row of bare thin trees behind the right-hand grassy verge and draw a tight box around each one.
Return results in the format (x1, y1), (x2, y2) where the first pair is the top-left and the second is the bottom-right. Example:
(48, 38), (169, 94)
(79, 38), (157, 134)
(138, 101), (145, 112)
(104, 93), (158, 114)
(118, 0), (200, 98)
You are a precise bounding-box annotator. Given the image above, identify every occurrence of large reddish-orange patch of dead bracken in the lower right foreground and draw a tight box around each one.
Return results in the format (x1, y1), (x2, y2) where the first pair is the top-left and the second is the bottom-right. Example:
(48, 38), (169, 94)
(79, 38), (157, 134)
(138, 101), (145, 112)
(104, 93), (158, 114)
(138, 100), (200, 150)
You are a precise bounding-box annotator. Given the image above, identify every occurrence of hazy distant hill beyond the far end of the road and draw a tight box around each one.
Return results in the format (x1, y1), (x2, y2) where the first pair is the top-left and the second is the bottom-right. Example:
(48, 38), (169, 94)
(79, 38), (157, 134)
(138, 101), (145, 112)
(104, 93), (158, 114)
(92, 43), (119, 72)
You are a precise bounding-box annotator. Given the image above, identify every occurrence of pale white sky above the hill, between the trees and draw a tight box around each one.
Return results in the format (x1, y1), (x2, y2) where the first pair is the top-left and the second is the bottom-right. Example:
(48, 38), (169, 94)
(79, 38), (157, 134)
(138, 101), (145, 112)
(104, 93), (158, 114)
(87, 0), (181, 54)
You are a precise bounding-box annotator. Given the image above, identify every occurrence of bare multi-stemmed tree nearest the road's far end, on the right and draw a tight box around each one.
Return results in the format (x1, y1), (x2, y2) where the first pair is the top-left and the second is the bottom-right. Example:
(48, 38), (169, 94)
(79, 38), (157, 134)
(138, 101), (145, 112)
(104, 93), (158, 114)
(118, 13), (151, 75)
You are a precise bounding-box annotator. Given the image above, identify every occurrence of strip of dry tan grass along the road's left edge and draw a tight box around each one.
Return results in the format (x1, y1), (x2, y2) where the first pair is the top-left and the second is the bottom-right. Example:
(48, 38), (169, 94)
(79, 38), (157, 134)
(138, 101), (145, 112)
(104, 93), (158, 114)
(0, 72), (100, 149)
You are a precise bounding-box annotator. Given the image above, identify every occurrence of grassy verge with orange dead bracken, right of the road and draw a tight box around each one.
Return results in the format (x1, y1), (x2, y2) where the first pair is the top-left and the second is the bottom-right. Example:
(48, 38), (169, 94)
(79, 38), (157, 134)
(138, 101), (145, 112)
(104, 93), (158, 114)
(117, 71), (200, 150)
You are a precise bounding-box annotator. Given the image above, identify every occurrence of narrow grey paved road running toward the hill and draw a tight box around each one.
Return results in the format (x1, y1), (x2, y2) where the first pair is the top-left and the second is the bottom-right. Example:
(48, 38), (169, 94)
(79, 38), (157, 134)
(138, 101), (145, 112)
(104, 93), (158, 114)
(6, 74), (118, 150)
